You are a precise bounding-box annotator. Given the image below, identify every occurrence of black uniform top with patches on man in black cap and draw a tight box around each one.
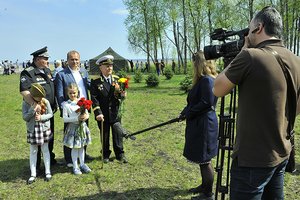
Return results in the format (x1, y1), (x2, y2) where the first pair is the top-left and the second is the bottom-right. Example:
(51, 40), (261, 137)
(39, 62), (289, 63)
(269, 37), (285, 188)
(20, 64), (57, 110)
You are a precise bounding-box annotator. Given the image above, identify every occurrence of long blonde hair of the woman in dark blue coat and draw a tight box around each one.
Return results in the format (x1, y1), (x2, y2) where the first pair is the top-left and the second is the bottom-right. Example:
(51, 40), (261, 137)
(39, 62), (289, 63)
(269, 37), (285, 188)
(193, 50), (218, 86)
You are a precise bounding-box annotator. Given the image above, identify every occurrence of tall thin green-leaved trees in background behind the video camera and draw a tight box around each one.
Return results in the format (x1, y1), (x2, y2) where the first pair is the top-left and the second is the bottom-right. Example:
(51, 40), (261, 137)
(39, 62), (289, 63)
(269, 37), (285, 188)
(123, 0), (300, 73)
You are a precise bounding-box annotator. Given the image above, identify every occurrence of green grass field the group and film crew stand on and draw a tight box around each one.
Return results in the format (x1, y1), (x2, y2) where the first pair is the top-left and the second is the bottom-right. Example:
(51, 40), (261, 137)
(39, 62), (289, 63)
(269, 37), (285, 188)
(0, 74), (300, 200)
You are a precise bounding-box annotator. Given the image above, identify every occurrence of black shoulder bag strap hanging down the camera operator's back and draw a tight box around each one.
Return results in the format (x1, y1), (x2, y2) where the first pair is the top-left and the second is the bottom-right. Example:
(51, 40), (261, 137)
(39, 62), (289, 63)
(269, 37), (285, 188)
(264, 47), (297, 173)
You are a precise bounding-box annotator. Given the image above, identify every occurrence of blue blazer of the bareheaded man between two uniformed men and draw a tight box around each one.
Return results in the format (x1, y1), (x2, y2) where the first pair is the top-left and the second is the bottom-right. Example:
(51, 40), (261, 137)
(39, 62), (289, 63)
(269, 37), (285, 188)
(55, 67), (90, 110)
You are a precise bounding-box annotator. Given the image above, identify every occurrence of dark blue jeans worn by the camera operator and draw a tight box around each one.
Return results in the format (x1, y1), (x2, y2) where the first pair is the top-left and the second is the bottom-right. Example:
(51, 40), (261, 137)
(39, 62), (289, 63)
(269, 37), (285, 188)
(230, 159), (288, 200)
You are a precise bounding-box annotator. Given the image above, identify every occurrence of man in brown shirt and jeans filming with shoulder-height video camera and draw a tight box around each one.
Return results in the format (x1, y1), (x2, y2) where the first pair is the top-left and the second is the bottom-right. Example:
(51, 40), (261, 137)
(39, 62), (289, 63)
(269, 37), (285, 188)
(213, 6), (300, 200)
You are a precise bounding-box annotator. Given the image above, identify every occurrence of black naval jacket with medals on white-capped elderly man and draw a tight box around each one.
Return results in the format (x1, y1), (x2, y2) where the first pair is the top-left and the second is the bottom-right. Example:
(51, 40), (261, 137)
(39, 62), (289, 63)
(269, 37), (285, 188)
(91, 76), (120, 123)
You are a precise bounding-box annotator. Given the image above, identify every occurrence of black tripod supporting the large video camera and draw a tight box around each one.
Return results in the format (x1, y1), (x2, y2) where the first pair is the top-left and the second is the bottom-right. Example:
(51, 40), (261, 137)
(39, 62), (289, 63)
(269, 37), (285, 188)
(215, 58), (237, 200)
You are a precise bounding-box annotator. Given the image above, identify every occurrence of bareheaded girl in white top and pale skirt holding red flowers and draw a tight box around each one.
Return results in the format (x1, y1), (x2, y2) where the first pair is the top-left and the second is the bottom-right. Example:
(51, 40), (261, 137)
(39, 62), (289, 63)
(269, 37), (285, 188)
(63, 83), (91, 175)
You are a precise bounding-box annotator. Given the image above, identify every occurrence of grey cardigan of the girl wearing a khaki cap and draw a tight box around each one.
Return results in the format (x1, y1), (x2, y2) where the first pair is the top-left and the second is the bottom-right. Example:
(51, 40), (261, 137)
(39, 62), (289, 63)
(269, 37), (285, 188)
(22, 99), (53, 133)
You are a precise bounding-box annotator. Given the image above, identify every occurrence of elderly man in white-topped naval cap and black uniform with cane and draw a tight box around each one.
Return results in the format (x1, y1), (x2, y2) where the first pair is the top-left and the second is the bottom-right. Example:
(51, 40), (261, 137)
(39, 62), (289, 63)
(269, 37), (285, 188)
(90, 55), (128, 163)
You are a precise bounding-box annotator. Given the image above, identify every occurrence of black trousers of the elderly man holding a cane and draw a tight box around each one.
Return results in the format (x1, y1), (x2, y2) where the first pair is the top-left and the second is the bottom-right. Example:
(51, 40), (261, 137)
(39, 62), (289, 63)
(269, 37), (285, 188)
(98, 121), (124, 159)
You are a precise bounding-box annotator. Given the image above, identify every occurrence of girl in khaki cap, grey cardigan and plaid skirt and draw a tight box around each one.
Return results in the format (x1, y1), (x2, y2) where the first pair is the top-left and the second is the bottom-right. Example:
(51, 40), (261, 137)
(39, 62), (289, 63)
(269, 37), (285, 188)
(22, 83), (53, 184)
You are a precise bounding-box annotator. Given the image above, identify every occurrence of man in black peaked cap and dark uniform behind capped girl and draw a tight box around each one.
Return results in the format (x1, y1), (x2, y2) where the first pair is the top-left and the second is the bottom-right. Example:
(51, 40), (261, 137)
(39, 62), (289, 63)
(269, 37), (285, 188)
(20, 47), (57, 168)
